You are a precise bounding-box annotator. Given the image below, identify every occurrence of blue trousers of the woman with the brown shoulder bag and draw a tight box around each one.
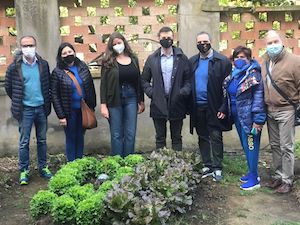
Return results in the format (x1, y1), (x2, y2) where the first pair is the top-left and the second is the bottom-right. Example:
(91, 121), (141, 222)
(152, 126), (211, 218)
(65, 109), (84, 162)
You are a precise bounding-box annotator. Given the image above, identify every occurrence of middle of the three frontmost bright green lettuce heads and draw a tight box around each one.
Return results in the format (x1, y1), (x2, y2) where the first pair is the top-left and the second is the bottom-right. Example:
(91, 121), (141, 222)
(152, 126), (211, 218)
(51, 195), (76, 224)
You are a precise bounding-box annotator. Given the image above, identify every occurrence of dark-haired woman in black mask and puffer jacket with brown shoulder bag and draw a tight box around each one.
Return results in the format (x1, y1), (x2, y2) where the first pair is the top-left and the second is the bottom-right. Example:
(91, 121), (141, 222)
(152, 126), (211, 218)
(51, 43), (96, 161)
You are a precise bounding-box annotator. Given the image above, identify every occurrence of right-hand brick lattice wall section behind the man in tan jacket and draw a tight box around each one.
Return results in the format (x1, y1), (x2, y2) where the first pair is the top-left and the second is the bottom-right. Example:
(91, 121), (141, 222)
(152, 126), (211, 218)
(220, 8), (300, 63)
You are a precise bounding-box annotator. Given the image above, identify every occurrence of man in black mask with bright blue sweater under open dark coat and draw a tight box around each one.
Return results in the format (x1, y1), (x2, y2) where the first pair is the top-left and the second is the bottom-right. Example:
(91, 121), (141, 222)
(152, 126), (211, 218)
(190, 32), (232, 181)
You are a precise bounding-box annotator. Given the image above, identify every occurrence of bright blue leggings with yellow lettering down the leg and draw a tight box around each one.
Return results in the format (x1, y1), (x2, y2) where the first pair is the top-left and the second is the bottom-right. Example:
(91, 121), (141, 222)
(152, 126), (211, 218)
(234, 117), (261, 176)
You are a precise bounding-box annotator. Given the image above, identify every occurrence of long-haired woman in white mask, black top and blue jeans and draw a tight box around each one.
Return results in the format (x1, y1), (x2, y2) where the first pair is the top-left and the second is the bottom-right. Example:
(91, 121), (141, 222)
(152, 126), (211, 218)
(100, 32), (145, 157)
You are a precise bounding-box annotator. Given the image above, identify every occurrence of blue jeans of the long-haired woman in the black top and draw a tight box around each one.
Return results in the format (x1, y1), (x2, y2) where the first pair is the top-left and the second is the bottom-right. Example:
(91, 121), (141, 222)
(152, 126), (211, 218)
(108, 85), (137, 157)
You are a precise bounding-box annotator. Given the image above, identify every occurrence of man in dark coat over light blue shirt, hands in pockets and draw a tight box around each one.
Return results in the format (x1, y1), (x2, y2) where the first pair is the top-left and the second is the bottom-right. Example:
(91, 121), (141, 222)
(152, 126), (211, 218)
(142, 27), (191, 151)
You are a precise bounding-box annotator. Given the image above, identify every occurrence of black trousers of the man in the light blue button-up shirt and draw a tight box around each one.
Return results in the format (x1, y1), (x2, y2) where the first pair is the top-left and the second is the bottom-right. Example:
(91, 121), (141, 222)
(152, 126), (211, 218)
(153, 118), (183, 151)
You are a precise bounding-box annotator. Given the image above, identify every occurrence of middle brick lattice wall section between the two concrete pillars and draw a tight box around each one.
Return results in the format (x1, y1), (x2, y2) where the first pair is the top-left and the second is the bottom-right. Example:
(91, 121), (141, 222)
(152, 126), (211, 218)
(59, 0), (178, 66)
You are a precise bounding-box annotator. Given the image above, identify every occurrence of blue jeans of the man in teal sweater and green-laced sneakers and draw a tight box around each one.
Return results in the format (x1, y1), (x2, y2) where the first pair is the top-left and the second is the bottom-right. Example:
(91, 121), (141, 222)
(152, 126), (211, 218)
(19, 106), (47, 171)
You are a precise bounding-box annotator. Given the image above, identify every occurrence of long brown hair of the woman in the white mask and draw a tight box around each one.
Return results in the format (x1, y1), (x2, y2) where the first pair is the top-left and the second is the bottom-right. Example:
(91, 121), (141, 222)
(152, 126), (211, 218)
(102, 32), (133, 68)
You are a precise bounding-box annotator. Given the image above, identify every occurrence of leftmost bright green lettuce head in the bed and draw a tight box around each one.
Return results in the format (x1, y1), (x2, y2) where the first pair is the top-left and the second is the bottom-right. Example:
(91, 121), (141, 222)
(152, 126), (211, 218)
(30, 190), (57, 219)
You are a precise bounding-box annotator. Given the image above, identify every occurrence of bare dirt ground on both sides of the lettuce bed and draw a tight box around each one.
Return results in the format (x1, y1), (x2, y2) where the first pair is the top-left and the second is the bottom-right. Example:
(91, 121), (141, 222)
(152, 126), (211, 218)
(0, 152), (300, 225)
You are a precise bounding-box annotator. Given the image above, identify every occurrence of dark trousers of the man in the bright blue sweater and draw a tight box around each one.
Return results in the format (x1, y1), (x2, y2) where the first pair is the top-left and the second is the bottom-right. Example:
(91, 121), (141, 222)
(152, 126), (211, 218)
(196, 106), (223, 169)
